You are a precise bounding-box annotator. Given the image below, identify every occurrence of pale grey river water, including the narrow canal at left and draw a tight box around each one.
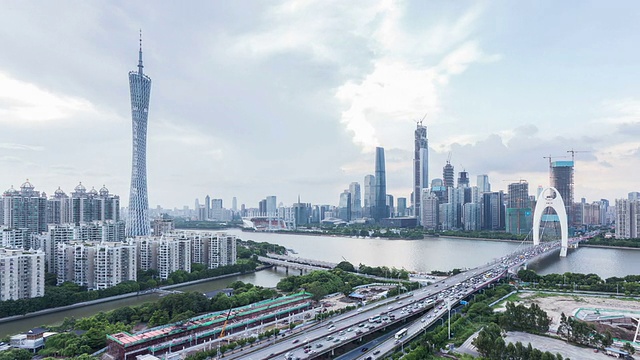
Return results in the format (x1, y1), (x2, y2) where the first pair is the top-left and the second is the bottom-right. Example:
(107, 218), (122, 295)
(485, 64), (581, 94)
(0, 229), (640, 337)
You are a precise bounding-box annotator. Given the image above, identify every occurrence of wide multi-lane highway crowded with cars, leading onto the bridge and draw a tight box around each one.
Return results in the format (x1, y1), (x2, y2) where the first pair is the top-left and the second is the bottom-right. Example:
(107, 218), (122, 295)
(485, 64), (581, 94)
(179, 238), (560, 360)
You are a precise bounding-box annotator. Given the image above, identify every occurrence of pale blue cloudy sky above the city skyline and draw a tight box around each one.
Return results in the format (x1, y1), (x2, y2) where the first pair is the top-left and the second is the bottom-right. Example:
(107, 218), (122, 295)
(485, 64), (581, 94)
(0, 0), (640, 208)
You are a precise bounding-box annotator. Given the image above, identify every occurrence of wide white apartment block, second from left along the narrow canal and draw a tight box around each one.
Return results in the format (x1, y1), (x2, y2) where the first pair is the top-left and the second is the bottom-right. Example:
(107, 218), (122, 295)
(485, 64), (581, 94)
(55, 241), (137, 290)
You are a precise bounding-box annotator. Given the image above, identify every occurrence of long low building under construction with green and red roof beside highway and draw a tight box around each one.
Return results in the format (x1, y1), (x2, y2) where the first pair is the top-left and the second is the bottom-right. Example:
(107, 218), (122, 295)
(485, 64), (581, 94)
(107, 292), (312, 360)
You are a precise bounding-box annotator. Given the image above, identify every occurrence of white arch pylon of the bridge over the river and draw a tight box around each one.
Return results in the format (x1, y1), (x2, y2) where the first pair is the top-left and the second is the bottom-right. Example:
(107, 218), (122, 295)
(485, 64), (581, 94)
(533, 187), (569, 257)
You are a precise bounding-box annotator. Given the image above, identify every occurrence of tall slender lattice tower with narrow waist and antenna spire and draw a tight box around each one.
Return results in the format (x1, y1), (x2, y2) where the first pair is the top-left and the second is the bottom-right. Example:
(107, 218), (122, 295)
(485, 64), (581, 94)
(127, 35), (152, 236)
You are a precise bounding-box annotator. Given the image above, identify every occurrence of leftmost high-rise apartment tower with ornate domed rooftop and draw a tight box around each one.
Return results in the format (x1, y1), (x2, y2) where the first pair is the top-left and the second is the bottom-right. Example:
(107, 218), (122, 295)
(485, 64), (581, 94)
(2, 180), (47, 236)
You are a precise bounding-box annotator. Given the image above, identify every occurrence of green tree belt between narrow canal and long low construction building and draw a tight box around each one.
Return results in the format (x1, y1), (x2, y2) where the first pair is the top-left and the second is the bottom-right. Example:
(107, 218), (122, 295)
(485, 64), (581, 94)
(39, 281), (278, 360)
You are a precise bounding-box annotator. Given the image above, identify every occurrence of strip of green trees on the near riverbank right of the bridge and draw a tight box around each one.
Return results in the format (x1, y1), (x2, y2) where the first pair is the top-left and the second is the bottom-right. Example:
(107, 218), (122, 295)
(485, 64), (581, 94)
(518, 270), (640, 295)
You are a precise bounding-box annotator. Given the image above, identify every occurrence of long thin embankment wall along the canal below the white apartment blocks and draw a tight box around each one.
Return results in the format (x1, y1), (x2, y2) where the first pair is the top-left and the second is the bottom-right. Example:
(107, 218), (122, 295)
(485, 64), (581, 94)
(0, 265), (272, 324)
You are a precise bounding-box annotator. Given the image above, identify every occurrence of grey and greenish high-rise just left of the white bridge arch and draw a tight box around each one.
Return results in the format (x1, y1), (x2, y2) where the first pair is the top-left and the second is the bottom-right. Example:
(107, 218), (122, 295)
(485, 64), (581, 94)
(505, 180), (533, 234)
